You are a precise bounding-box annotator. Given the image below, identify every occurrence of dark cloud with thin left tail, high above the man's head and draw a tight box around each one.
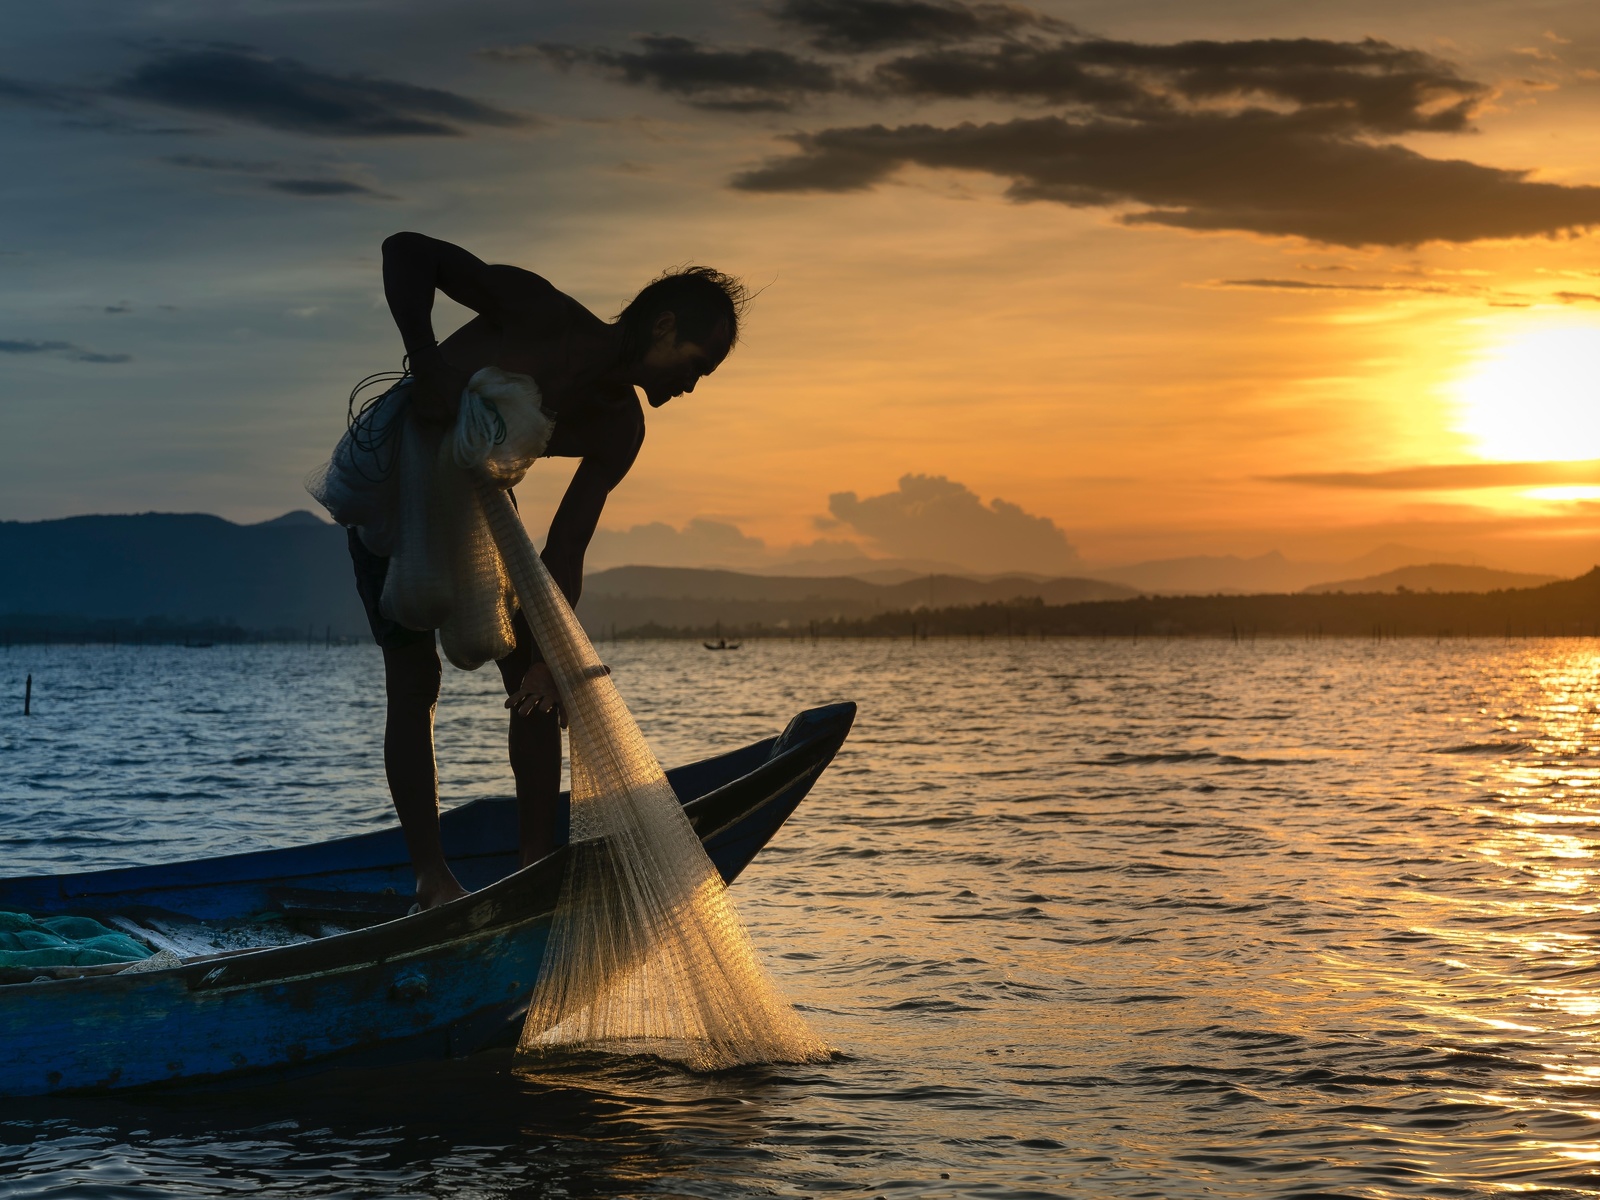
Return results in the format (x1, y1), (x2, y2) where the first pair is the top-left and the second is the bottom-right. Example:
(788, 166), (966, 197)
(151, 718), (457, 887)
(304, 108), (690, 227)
(508, 35), (838, 112)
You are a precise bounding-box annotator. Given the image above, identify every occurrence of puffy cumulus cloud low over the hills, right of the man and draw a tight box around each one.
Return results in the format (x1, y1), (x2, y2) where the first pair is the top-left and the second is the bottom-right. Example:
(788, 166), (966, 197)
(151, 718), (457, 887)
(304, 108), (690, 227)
(827, 475), (1080, 573)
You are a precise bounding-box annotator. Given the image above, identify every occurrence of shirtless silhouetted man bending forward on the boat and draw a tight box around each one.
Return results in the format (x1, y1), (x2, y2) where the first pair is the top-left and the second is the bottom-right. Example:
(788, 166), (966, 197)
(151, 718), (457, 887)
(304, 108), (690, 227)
(361, 234), (744, 909)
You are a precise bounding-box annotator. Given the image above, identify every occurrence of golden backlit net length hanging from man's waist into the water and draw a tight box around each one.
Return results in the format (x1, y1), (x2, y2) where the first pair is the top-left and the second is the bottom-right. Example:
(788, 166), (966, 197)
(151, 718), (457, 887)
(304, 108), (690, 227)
(478, 482), (829, 1070)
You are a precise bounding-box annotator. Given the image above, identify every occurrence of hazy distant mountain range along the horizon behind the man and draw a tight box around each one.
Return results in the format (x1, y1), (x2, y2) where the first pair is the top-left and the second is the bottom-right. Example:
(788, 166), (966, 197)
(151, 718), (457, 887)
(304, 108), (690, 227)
(0, 512), (1574, 638)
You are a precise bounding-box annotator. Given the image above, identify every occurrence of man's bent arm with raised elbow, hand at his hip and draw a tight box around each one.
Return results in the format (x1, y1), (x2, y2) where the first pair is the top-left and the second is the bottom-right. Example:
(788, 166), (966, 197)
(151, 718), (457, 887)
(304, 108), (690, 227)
(384, 234), (562, 421)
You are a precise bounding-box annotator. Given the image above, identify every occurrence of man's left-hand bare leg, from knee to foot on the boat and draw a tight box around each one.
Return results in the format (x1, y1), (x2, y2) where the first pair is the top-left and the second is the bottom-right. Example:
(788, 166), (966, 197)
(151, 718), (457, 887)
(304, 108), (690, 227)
(384, 637), (467, 909)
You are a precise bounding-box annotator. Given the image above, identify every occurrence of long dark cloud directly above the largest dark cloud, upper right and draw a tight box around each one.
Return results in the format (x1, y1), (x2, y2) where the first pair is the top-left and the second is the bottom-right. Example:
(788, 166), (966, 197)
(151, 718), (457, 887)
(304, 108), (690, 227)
(874, 38), (1490, 133)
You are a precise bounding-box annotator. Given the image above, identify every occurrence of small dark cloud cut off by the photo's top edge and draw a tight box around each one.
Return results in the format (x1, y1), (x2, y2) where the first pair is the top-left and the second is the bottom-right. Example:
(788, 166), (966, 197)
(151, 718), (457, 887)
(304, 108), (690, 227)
(773, 0), (1064, 53)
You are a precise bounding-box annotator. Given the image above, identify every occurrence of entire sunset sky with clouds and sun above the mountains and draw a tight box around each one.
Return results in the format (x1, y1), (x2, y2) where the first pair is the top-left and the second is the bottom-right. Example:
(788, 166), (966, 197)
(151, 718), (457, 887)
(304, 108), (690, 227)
(0, 0), (1600, 573)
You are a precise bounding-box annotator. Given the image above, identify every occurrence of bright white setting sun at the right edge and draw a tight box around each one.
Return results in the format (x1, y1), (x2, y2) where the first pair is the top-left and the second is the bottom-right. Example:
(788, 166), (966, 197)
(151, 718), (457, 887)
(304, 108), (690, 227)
(1451, 322), (1600, 462)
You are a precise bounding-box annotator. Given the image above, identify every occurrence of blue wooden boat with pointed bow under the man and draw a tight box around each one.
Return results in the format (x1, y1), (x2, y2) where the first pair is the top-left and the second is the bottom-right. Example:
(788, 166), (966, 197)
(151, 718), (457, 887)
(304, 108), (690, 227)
(0, 704), (856, 1096)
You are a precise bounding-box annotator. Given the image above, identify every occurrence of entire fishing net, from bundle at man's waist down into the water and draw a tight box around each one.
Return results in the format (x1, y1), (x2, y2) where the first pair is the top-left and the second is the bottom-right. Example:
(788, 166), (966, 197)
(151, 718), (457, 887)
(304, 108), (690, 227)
(314, 371), (829, 1070)
